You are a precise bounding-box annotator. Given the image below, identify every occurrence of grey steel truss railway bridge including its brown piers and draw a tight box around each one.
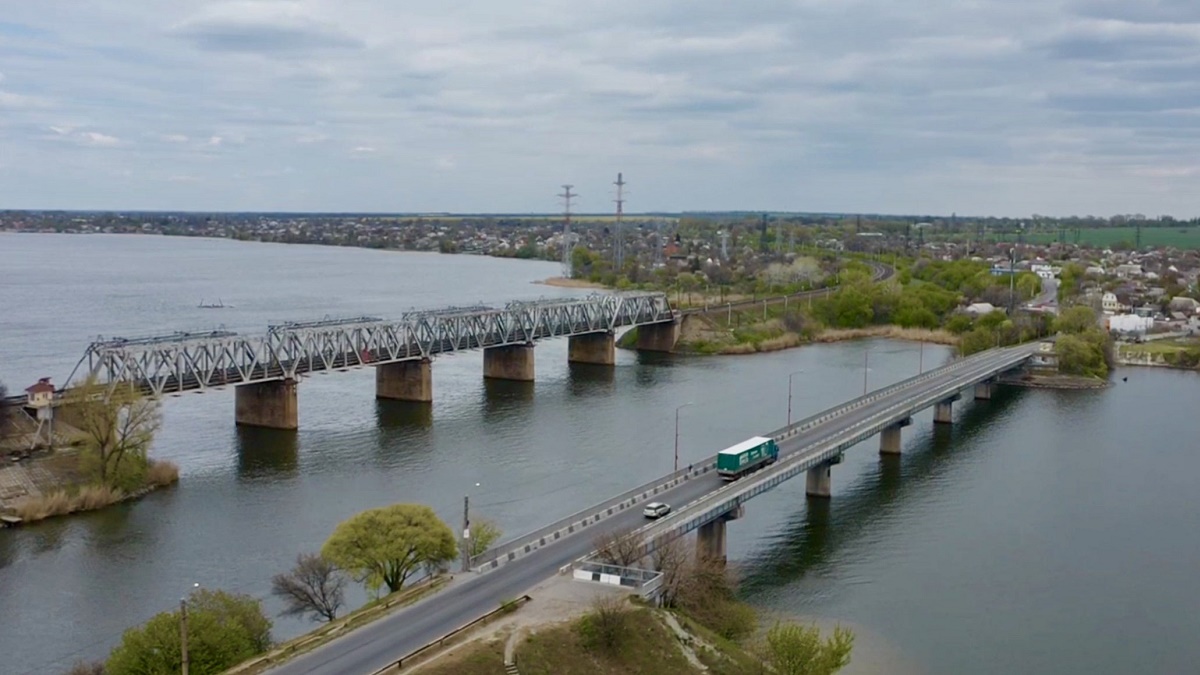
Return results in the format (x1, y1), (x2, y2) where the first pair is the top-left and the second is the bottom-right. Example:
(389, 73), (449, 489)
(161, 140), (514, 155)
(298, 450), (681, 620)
(7, 291), (679, 429)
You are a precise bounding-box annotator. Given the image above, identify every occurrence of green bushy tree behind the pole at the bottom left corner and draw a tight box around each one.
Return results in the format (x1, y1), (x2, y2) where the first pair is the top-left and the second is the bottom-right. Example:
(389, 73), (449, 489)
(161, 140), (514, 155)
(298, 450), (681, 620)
(104, 590), (271, 675)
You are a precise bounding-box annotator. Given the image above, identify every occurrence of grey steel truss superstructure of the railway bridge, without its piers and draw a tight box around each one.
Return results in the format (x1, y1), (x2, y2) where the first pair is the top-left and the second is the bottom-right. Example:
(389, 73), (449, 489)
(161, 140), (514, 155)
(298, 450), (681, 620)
(60, 291), (678, 396)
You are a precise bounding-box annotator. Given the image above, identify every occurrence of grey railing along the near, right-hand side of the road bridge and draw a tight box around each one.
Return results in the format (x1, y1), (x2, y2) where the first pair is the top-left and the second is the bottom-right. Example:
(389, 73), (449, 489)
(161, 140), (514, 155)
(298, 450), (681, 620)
(619, 348), (1036, 542)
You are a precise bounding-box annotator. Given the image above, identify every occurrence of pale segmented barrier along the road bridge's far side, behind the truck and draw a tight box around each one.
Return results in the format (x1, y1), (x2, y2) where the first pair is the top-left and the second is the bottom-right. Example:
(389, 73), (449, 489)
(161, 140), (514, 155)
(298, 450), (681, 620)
(470, 347), (1041, 573)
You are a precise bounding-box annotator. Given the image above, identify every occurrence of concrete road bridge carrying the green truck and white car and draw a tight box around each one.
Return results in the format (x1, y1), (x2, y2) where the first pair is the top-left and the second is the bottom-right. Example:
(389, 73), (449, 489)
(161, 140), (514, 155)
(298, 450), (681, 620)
(271, 342), (1052, 675)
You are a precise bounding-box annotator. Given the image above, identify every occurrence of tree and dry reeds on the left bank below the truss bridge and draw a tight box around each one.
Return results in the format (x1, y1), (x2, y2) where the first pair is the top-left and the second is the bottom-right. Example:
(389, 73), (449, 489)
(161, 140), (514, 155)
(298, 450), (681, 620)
(5, 381), (179, 522)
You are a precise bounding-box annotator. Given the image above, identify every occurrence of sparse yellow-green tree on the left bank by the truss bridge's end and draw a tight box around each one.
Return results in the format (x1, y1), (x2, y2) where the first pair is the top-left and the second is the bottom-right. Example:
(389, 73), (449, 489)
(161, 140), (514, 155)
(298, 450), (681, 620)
(65, 378), (162, 490)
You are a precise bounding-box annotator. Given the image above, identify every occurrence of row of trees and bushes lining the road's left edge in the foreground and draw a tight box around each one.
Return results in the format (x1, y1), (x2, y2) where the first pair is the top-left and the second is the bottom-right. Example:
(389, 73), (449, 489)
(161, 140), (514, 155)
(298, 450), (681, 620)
(67, 503), (502, 675)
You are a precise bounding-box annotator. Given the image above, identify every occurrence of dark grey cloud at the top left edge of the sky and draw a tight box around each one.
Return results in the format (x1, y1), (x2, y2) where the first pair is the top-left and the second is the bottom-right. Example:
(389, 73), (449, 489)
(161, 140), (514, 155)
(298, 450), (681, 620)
(172, 0), (364, 54)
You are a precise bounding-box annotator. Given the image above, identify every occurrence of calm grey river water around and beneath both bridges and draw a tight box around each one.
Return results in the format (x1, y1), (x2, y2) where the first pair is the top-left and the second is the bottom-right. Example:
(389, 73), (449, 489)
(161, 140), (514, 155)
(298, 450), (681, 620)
(0, 235), (1200, 675)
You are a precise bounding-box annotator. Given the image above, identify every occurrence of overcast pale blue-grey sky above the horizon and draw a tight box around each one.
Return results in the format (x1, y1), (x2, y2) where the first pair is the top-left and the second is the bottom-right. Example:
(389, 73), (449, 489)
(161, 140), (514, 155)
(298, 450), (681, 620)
(0, 0), (1200, 217)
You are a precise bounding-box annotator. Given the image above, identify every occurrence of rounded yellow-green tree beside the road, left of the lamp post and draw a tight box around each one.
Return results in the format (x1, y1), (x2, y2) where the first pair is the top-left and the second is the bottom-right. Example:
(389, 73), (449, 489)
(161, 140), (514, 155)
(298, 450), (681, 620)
(320, 504), (457, 592)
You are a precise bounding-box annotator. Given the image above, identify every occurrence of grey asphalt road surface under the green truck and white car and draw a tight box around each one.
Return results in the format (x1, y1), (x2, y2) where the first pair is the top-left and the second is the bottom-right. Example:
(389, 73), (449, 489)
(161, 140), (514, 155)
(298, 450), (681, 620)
(269, 343), (1027, 675)
